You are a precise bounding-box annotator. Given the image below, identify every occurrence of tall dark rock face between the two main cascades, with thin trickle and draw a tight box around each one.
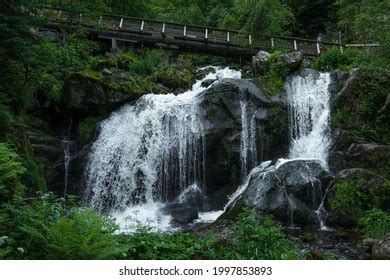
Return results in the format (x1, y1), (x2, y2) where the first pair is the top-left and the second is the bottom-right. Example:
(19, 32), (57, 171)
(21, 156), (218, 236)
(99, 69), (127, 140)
(200, 79), (288, 209)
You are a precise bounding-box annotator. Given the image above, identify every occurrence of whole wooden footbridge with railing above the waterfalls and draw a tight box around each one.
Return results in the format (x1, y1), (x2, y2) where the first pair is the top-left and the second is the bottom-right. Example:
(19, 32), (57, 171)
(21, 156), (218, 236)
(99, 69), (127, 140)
(39, 7), (343, 59)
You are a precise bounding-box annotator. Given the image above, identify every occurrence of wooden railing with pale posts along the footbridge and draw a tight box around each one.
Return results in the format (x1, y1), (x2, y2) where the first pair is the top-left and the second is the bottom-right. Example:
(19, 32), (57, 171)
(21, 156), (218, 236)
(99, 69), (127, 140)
(37, 7), (343, 56)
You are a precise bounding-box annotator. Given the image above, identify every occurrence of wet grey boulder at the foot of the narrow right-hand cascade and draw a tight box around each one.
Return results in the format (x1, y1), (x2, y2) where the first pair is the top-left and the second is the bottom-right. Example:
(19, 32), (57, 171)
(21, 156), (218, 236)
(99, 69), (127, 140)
(222, 160), (332, 225)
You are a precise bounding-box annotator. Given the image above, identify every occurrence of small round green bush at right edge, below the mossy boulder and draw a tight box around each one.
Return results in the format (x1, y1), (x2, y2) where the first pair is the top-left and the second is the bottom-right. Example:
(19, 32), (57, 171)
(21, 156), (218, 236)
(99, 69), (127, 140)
(359, 208), (390, 238)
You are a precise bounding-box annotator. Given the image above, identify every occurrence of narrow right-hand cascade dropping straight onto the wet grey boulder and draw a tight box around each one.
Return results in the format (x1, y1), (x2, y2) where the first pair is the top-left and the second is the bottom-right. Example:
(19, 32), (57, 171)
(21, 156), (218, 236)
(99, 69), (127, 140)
(286, 72), (331, 166)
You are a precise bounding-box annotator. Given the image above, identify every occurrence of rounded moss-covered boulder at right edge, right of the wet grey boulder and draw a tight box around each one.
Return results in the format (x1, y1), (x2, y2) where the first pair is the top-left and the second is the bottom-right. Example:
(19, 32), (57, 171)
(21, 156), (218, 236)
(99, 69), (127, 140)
(324, 168), (390, 228)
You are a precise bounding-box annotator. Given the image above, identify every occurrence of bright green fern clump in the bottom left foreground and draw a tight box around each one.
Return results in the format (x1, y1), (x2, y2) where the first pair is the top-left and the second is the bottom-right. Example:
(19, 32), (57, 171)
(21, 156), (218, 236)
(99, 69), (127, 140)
(0, 193), (125, 259)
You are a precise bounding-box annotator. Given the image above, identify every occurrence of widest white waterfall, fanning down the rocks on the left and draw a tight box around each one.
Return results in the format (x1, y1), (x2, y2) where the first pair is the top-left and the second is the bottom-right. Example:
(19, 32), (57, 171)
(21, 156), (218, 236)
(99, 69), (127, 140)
(85, 68), (241, 231)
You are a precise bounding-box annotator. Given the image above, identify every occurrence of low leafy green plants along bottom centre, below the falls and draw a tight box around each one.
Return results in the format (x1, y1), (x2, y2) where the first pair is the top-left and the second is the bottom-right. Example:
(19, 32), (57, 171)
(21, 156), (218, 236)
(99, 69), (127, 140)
(118, 211), (299, 259)
